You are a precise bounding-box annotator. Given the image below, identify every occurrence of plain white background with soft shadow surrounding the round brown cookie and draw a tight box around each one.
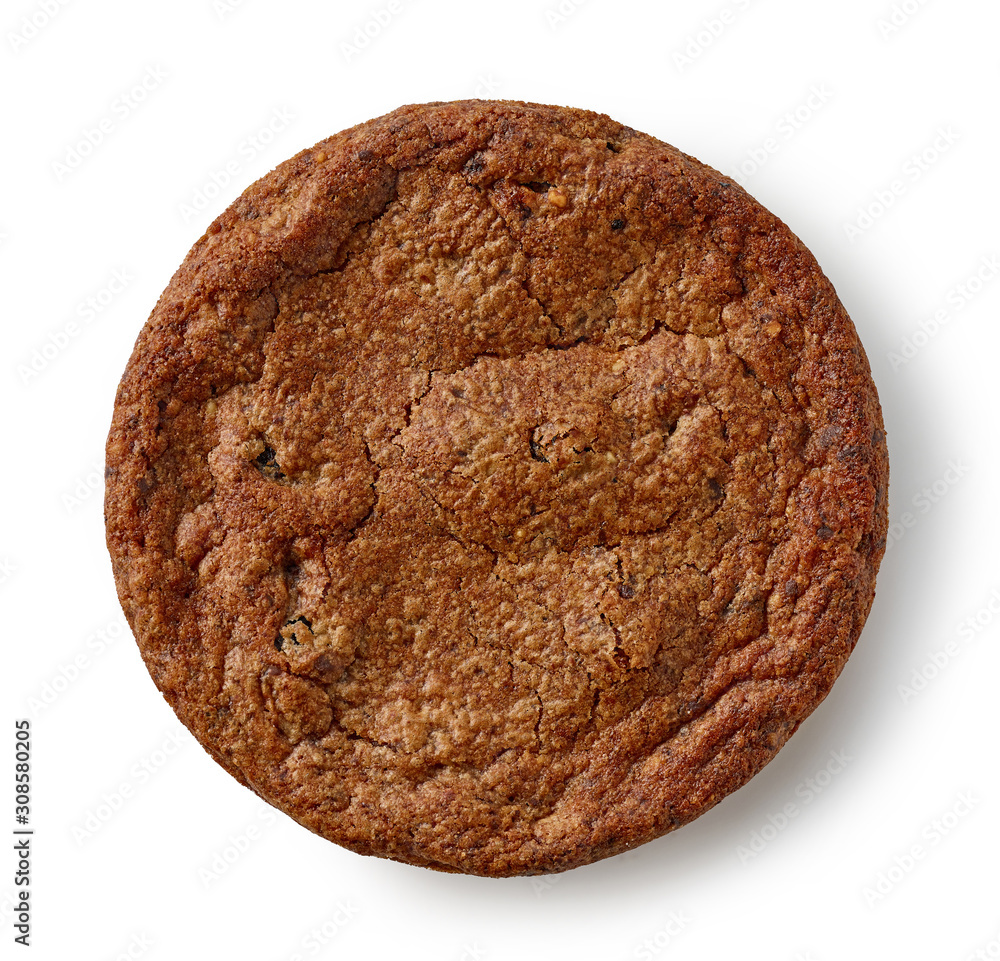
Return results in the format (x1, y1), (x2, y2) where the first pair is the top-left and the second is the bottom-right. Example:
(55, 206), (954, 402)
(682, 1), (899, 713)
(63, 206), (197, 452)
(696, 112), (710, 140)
(0, 0), (1000, 961)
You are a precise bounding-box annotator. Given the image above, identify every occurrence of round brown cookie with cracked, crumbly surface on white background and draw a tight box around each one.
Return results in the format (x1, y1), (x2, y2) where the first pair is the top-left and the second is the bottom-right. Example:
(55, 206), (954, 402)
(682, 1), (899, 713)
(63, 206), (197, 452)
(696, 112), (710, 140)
(106, 101), (888, 876)
